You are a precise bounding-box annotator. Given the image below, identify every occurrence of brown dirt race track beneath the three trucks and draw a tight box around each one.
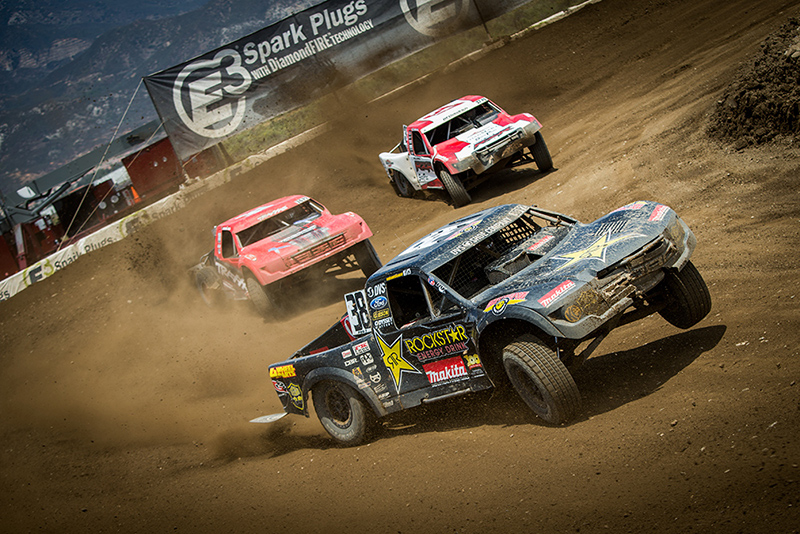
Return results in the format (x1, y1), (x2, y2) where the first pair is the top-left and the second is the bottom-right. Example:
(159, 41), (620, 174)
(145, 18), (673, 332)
(0, 0), (800, 532)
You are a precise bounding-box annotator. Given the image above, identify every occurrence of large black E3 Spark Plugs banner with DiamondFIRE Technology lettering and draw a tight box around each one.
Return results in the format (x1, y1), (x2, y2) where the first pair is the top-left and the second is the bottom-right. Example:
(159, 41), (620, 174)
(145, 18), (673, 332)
(144, 0), (527, 160)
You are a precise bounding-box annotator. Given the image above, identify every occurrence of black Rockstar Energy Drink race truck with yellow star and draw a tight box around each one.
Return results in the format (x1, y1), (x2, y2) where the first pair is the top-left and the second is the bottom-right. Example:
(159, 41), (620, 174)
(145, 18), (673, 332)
(253, 201), (711, 445)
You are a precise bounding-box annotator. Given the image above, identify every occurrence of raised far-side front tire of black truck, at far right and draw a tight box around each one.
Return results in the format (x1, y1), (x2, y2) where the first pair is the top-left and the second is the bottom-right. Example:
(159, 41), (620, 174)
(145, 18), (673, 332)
(659, 262), (711, 329)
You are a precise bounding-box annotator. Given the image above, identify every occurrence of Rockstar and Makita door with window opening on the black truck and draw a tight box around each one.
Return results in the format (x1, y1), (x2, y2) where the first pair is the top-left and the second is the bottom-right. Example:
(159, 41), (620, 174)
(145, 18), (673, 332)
(370, 274), (491, 407)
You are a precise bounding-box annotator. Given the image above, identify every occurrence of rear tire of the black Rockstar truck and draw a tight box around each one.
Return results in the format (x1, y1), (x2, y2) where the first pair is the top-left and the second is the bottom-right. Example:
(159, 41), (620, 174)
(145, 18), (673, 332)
(311, 381), (372, 446)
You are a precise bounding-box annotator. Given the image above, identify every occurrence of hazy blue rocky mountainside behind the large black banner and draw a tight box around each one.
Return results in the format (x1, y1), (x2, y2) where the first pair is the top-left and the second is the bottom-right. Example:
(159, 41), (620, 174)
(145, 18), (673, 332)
(0, 0), (315, 197)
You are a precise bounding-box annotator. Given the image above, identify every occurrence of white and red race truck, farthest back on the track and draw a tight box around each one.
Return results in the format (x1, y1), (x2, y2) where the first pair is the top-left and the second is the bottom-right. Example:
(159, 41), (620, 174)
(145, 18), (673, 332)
(378, 95), (553, 208)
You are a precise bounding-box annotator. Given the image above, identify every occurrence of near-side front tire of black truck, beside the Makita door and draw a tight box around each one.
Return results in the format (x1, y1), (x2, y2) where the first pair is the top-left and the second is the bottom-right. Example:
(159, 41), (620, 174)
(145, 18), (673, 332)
(503, 336), (581, 425)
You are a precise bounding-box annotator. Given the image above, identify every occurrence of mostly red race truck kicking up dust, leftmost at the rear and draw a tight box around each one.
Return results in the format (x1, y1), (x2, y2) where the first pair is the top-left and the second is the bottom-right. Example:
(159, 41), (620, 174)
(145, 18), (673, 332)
(191, 195), (381, 314)
